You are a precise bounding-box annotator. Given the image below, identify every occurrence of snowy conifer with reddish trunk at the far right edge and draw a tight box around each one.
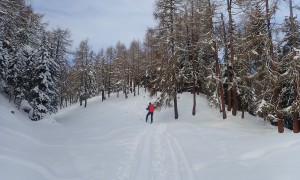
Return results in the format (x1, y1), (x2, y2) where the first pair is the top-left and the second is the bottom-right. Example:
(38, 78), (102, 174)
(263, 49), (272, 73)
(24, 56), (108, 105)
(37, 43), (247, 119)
(279, 0), (300, 133)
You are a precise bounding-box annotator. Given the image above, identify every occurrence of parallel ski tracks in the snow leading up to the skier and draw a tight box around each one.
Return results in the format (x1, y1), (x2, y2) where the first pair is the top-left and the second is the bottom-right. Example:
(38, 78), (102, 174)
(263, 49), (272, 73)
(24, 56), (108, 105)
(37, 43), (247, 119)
(116, 123), (195, 180)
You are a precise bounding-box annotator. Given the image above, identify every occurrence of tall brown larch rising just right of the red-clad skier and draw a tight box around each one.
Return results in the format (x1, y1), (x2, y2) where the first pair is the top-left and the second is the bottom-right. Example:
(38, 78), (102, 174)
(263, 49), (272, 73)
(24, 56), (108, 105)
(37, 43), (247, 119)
(150, 0), (183, 119)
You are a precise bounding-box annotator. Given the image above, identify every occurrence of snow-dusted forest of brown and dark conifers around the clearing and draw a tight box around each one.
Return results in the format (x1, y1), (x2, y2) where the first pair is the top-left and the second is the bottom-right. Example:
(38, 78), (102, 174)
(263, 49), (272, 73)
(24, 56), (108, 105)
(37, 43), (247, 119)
(0, 0), (300, 133)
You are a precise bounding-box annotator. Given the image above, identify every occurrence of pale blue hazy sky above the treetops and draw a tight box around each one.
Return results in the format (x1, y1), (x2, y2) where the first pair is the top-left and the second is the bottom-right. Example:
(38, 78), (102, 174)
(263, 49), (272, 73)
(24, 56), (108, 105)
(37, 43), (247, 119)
(31, 0), (155, 50)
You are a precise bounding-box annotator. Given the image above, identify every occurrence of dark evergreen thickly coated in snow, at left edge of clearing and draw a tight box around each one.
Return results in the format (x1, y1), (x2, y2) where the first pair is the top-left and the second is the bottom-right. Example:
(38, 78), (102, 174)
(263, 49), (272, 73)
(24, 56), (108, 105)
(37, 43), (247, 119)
(30, 35), (59, 121)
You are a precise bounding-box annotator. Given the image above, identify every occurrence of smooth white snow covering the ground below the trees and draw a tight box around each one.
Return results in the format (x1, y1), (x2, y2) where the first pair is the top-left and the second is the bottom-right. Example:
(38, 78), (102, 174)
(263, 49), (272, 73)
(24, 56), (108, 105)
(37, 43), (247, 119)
(0, 93), (300, 180)
